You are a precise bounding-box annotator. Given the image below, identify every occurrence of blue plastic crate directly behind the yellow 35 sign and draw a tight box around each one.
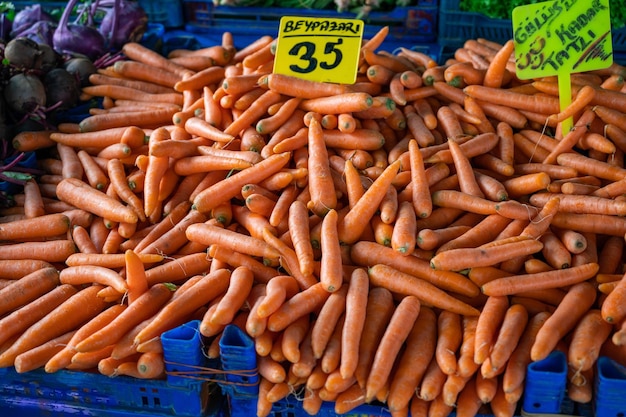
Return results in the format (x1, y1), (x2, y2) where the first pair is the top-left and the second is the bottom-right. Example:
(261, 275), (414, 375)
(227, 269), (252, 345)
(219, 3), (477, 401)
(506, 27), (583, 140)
(183, 0), (438, 50)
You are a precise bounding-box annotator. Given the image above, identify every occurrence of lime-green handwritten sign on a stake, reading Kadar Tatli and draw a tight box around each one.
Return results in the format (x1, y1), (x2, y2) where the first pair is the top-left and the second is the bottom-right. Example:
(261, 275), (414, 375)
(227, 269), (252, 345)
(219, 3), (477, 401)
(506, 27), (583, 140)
(512, 0), (613, 132)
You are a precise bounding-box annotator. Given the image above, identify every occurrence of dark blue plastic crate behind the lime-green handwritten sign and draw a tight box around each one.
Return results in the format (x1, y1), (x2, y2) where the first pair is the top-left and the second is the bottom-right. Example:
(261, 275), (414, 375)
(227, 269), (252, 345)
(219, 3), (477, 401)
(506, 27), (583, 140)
(437, 0), (626, 52)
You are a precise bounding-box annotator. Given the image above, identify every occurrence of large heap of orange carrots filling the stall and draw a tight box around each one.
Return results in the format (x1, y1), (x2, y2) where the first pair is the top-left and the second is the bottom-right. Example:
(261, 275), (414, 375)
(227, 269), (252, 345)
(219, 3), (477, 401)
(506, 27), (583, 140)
(0, 28), (626, 417)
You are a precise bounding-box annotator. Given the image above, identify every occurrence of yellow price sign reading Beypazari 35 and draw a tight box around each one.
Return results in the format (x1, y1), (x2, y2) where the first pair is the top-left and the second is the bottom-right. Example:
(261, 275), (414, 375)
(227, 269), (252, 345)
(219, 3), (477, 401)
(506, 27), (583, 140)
(273, 16), (364, 84)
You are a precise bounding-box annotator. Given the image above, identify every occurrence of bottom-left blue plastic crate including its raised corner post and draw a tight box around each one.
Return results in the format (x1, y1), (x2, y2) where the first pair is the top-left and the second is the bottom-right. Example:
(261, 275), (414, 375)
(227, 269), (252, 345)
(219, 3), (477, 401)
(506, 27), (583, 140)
(0, 322), (224, 417)
